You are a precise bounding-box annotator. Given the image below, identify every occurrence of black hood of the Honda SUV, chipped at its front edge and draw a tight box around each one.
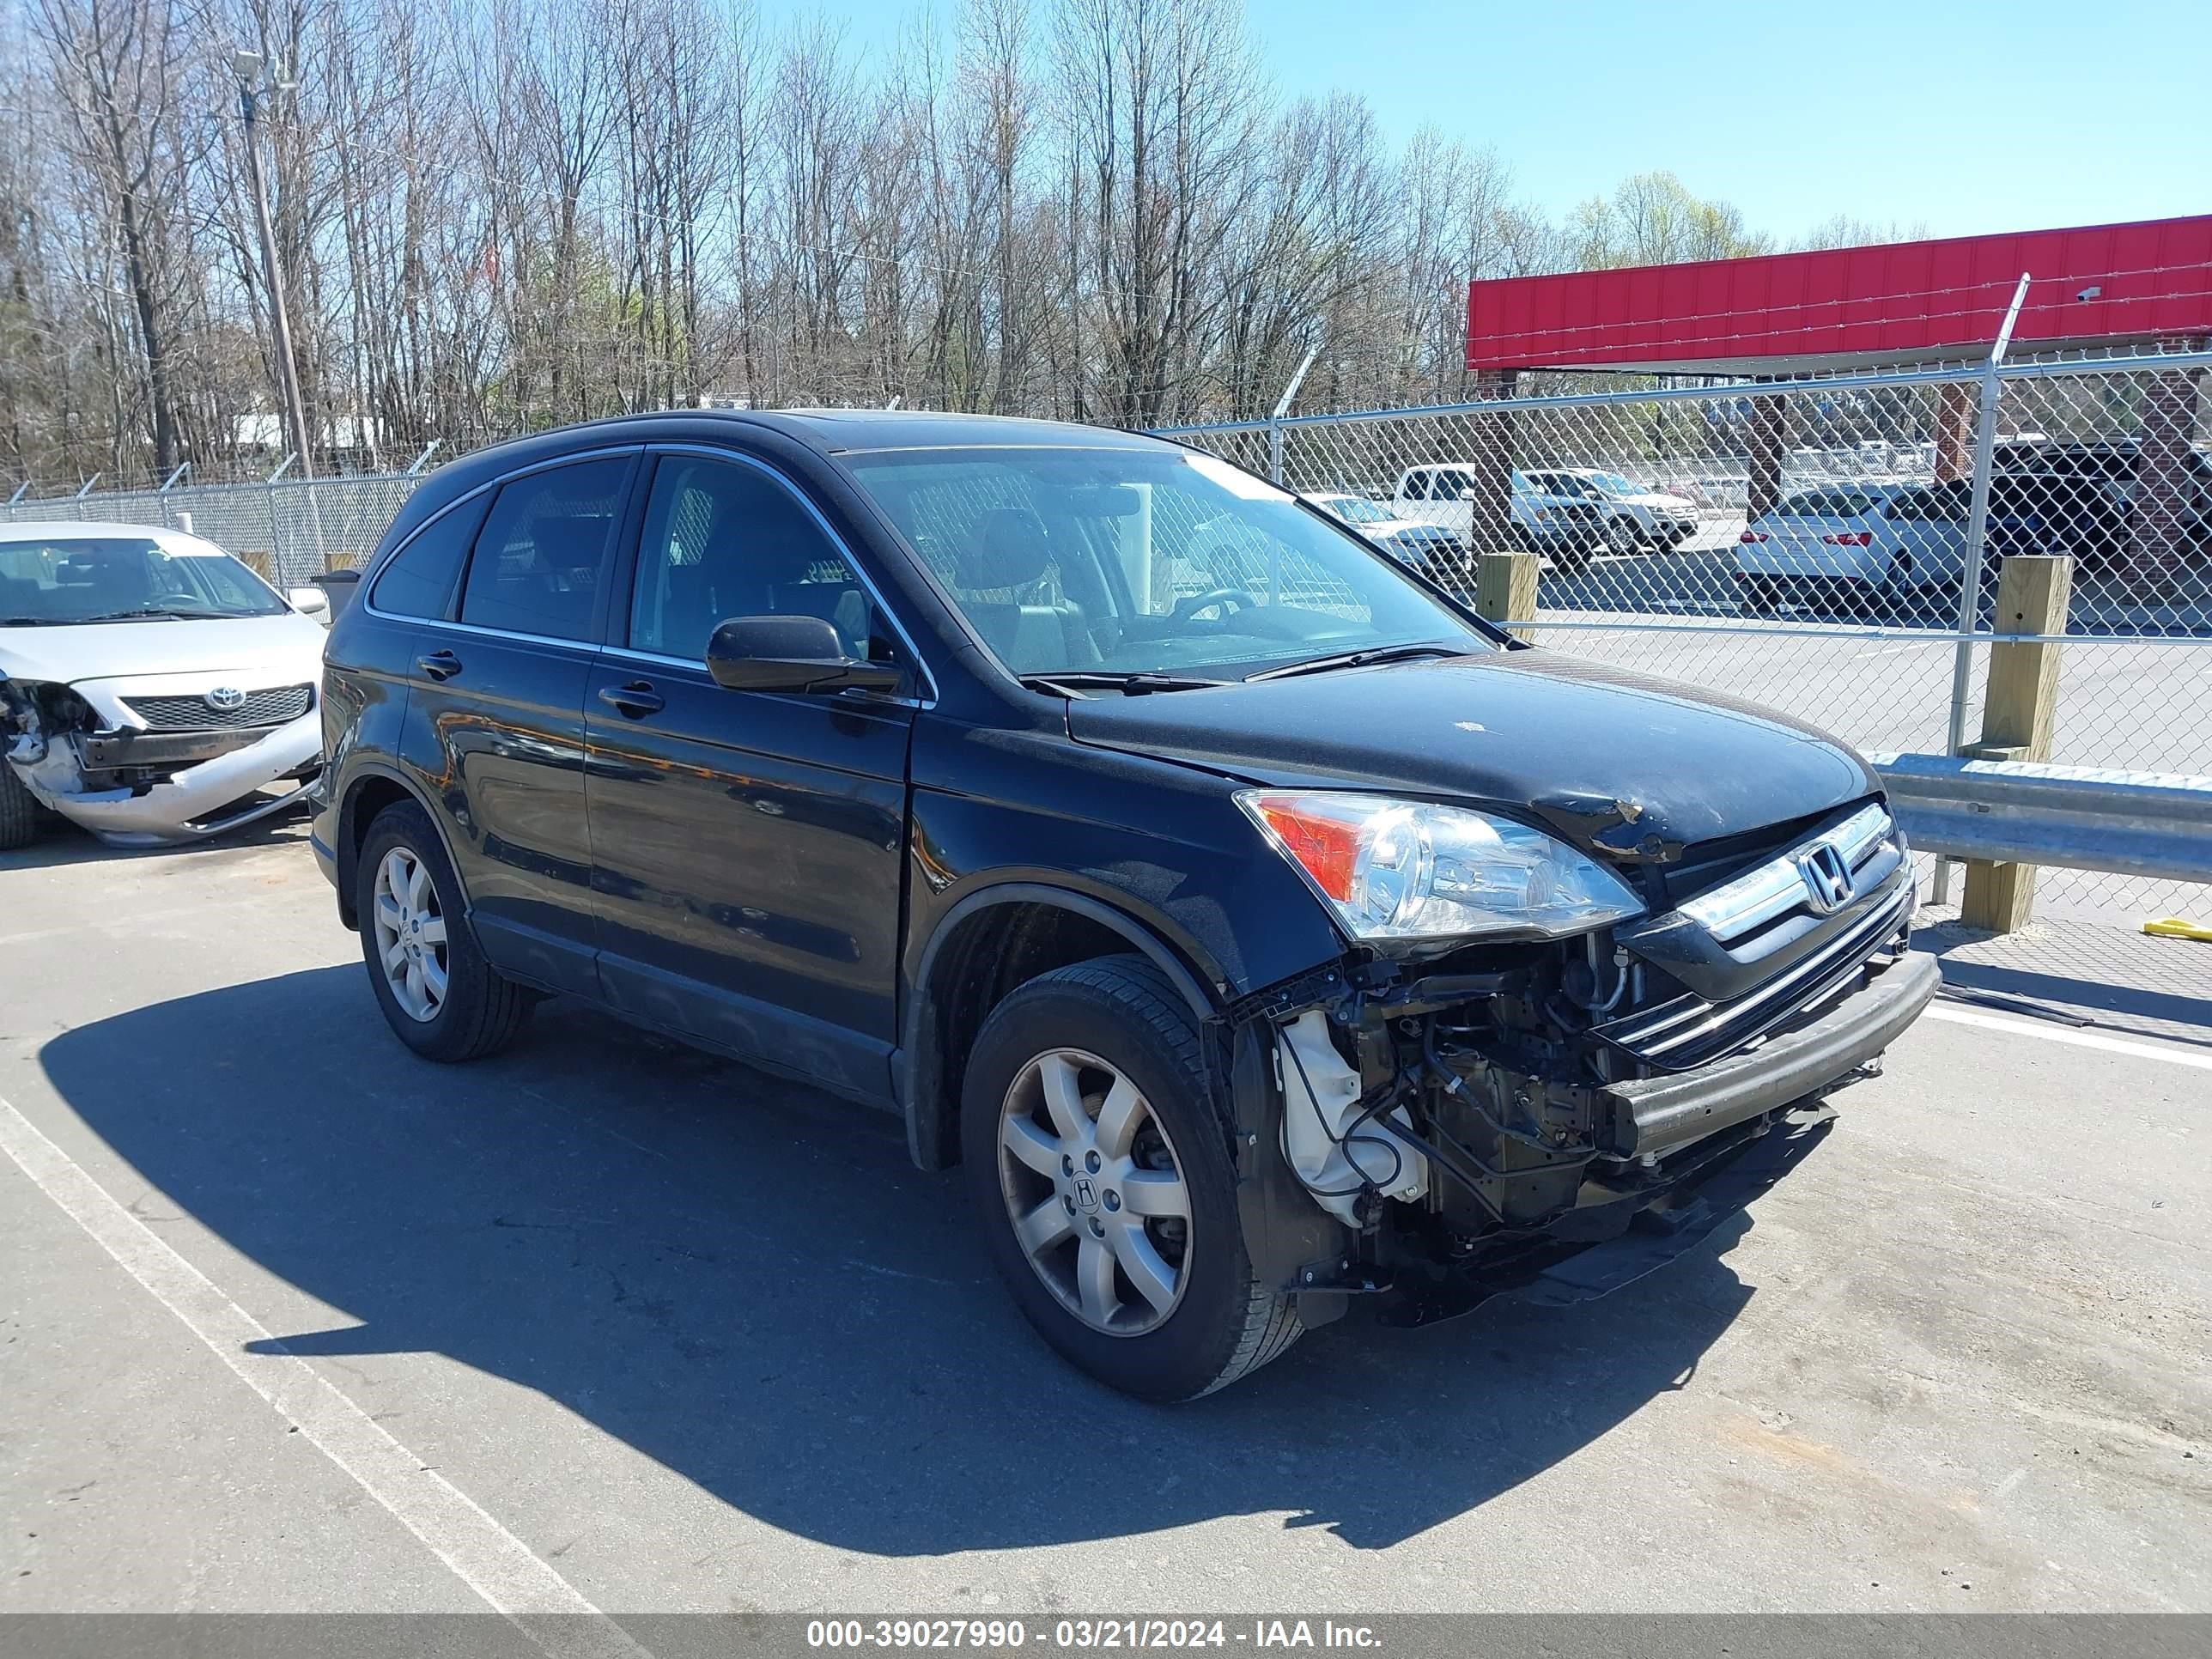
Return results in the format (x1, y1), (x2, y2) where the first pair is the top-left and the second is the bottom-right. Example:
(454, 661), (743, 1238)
(1068, 650), (1881, 858)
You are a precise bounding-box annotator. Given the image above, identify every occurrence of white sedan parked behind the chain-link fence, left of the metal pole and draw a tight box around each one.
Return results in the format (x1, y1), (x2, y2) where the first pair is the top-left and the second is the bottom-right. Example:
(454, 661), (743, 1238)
(1736, 480), (1971, 622)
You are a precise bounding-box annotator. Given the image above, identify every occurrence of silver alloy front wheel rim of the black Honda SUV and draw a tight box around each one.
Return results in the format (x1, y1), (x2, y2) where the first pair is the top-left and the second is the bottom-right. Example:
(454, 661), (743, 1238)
(998, 1048), (1190, 1336)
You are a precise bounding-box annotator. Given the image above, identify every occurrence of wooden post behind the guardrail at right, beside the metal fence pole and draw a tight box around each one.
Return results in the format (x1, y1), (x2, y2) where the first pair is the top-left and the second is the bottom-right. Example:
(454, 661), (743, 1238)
(1958, 553), (2073, 933)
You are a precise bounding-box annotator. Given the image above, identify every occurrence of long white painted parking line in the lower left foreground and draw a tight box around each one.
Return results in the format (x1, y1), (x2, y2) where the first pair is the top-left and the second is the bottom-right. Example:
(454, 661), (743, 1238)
(0, 1099), (648, 1659)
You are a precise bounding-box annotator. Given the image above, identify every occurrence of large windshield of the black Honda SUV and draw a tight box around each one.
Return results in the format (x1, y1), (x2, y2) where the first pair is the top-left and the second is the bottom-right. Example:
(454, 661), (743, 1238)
(845, 449), (1495, 679)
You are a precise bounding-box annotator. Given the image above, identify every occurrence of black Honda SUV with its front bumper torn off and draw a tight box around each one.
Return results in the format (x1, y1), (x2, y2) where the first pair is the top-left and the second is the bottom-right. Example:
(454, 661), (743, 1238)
(314, 411), (1936, 1398)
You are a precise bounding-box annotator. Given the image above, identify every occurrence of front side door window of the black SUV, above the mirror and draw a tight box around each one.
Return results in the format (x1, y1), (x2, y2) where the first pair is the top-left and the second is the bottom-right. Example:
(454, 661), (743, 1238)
(630, 456), (874, 661)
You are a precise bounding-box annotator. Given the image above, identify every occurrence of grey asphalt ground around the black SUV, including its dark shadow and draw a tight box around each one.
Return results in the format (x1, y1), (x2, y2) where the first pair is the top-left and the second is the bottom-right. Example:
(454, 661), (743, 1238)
(0, 825), (2212, 1617)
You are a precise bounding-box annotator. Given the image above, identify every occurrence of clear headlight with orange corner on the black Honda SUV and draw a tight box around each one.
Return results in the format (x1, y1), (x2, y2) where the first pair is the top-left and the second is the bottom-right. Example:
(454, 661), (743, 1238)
(1237, 790), (1644, 940)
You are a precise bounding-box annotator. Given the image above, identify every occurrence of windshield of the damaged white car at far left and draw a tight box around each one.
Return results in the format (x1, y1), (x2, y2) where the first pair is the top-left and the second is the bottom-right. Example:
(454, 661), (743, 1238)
(0, 535), (285, 629)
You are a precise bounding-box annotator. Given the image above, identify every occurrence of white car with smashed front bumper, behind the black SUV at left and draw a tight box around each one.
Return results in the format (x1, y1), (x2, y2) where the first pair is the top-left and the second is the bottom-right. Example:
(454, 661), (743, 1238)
(0, 522), (325, 848)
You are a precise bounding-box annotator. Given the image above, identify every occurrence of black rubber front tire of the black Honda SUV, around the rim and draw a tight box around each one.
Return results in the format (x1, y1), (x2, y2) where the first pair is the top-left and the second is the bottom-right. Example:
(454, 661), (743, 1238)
(960, 956), (1305, 1401)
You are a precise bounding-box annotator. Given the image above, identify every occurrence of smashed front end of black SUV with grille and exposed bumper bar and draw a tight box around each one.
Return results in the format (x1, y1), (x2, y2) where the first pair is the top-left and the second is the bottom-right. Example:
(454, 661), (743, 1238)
(1224, 803), (1938, 1322)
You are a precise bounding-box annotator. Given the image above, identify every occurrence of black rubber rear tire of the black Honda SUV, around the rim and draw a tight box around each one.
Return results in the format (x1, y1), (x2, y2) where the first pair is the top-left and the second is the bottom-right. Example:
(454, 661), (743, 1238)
(354, 803), (535, 1064)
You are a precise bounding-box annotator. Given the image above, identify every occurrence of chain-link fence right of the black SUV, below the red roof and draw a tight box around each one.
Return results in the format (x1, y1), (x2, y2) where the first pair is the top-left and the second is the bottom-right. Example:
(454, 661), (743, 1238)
(1164, 352), (2212, 918)
